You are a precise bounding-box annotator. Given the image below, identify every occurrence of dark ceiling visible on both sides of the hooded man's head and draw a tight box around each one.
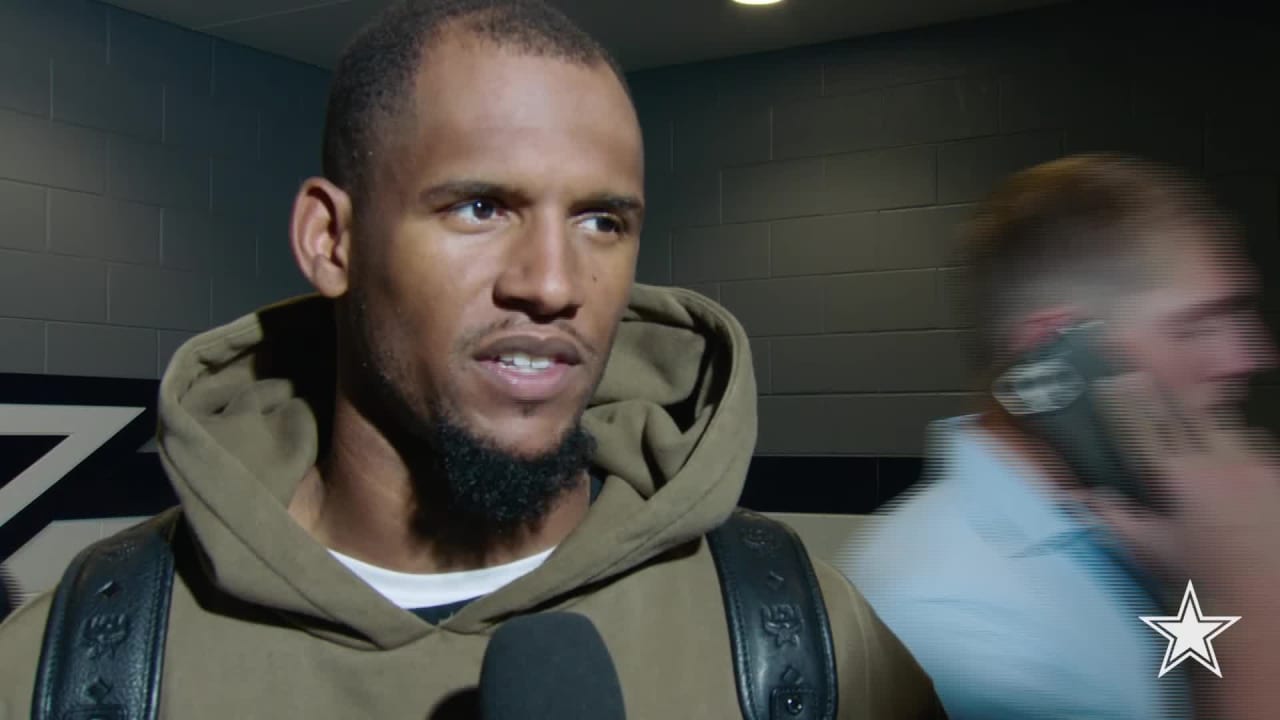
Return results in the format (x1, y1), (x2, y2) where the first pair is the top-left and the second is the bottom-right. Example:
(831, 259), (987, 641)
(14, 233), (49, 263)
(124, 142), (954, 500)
(99, 0), (1056, 70)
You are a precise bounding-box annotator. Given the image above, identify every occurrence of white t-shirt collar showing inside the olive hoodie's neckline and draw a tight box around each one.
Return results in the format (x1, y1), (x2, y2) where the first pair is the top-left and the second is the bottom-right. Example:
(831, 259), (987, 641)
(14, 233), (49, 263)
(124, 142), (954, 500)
(329, 548), (556, 610)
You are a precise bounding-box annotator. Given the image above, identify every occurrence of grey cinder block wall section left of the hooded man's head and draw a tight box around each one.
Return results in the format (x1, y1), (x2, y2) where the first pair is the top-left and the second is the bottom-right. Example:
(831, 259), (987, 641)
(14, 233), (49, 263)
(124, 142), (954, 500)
(0, 0), (328, 378)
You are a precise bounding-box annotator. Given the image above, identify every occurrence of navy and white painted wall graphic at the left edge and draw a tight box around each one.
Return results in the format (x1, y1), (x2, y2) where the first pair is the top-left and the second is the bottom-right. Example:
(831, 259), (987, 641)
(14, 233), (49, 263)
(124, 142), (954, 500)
(0, 368), (177, 609)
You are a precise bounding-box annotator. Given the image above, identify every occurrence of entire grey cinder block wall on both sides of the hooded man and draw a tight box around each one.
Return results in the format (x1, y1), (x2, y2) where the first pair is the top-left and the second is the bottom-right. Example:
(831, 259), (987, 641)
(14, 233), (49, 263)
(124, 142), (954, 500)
(0, 0), (1280, 456)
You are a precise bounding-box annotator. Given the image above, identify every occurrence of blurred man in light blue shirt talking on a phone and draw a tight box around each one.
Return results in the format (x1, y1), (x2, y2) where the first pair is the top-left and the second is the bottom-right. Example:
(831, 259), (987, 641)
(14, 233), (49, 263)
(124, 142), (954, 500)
(837, 155), (1280, 719)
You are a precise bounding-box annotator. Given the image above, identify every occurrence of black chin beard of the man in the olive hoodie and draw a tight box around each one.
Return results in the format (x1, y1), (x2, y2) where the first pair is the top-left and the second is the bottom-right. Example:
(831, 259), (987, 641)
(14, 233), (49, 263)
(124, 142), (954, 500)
(419, 409), (595, 536)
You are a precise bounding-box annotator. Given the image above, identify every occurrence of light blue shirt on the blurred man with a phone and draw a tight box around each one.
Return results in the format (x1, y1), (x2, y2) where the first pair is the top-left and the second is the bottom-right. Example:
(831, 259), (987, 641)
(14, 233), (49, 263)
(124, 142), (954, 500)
(837, 416), (1190, 720)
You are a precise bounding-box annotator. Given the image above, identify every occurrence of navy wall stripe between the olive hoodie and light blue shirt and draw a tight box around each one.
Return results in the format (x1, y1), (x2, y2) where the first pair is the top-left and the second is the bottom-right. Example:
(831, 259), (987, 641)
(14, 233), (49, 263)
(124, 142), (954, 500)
(740, 455), (923, 515)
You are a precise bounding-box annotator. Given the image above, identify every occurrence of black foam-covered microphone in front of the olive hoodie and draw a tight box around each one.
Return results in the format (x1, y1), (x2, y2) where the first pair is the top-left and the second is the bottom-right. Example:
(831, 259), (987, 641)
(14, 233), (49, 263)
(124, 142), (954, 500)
(480, 612), (626, 720)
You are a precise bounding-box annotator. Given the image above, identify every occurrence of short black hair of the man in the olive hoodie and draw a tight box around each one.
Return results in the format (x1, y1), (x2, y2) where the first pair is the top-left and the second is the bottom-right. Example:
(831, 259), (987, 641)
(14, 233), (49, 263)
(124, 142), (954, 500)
(321, 0), (630, 205)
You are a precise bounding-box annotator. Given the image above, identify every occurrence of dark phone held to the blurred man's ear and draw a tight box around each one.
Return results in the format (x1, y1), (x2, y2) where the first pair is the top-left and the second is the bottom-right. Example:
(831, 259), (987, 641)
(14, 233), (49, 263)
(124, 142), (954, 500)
(992, 320), (1162, 510)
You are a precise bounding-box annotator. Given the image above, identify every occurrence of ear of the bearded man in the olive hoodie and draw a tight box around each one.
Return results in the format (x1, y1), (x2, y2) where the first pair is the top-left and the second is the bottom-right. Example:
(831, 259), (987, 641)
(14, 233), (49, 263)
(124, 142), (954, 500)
(289, 178), (352, 297)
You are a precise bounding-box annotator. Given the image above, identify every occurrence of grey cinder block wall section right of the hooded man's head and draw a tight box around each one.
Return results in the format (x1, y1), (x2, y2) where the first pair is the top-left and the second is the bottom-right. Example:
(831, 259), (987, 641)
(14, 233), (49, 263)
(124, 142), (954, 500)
(634, 4), (1280, 457)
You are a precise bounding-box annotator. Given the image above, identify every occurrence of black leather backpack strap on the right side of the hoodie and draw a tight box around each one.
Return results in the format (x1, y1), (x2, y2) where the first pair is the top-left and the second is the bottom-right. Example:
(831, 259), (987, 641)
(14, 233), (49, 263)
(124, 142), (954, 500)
(707, 509), (838, 720)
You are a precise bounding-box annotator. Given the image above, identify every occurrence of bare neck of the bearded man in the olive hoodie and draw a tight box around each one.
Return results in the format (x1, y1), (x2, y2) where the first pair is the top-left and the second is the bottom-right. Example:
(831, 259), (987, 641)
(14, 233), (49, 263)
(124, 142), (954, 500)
(289, 392), (590, 574)
